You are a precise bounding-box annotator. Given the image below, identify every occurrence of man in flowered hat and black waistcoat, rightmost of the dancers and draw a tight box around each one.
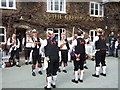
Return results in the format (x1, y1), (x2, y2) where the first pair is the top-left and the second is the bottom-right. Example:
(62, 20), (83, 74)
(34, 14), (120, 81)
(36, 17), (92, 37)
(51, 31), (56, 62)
(92, 28), (107, 77)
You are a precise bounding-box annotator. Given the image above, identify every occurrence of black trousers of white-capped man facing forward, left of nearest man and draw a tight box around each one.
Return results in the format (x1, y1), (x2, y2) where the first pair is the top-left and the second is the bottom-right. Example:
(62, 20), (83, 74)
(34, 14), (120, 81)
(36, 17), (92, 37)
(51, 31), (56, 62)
(32, 49), (41, 65)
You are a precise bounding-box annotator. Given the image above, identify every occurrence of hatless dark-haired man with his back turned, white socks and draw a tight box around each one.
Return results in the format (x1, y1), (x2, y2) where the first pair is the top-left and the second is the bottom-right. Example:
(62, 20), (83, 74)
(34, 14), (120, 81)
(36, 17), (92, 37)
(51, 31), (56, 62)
(72, 31), (85, 83)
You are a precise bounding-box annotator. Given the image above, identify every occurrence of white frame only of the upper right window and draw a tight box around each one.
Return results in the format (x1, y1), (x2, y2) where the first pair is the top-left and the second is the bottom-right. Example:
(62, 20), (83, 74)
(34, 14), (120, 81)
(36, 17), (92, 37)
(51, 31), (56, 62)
(89, 2), (104, 17)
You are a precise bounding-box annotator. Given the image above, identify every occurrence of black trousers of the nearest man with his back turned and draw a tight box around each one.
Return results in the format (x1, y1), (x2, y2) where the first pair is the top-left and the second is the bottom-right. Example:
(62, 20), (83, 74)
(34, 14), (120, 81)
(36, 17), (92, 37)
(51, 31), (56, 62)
(46, 59), (59, 77)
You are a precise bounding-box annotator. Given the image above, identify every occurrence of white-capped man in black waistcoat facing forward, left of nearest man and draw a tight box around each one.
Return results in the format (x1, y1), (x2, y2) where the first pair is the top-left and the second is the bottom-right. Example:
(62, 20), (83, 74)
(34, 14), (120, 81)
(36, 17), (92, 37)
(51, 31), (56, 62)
(32, 29), (42, 76)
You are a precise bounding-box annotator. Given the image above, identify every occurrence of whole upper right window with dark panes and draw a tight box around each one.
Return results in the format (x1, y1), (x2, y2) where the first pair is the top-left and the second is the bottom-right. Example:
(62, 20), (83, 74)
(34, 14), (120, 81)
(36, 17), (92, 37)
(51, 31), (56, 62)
(90, 2), (103, 17)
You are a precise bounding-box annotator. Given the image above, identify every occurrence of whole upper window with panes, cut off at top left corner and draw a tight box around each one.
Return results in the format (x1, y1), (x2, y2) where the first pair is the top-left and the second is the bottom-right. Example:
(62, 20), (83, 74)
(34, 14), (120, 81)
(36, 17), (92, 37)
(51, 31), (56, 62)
(0, 0), (16, 9)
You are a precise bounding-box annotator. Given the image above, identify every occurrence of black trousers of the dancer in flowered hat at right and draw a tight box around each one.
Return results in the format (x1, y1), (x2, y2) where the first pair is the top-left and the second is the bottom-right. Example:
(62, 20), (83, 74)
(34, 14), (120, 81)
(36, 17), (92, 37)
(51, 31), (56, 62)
(95, 50), (106, 67)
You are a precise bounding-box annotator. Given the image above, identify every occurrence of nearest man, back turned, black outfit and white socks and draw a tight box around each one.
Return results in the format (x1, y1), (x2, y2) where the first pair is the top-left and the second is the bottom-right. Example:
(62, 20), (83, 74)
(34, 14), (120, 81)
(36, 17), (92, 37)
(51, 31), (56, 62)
(42, 32), (59, 89)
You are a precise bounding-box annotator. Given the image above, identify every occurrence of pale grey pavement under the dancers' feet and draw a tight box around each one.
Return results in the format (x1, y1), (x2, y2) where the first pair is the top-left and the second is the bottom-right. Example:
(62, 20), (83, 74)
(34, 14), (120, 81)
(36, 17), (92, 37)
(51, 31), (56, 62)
(0, 57), (118, 88)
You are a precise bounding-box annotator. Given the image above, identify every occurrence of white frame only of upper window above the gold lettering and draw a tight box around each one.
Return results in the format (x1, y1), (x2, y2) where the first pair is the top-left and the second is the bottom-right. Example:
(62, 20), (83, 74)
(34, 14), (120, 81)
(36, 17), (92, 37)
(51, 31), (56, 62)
(47, 0), (66, 13)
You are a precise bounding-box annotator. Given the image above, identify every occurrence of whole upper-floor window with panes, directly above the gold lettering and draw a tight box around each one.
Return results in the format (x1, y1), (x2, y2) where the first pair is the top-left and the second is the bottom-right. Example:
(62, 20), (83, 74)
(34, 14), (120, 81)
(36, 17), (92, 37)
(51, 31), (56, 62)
(47, 0), (66, 13)
